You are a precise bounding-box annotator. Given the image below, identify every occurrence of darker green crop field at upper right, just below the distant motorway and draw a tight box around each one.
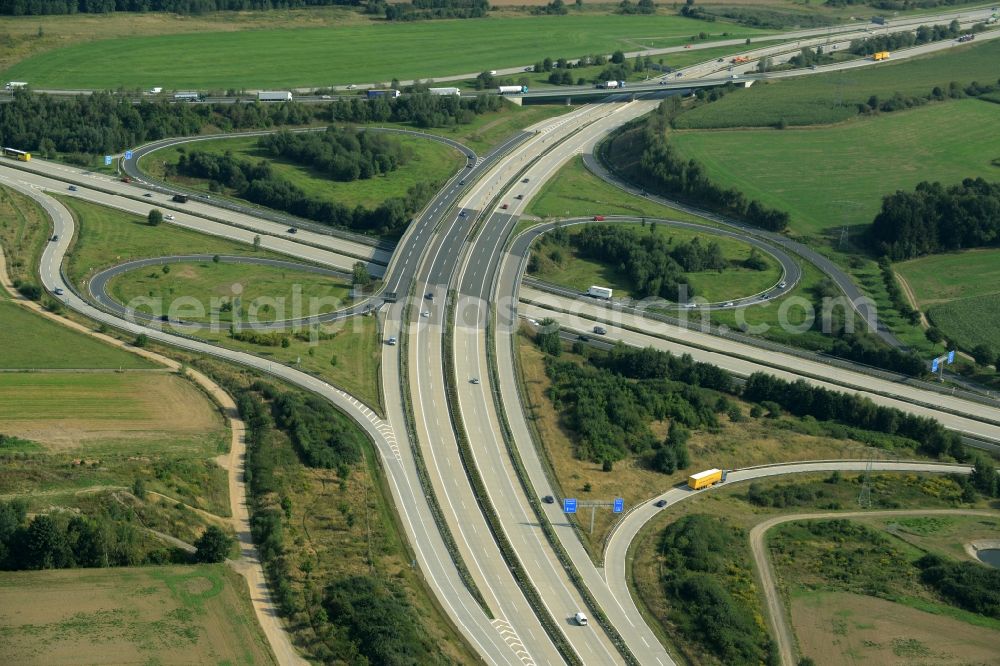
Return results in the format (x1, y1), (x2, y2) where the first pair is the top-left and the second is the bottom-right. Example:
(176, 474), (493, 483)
(676, 40), (1000, 129)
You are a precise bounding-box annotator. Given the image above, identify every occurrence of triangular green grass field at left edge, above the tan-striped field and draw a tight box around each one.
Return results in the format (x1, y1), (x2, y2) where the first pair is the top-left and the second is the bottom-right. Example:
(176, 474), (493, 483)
(0, 300), (155, 369)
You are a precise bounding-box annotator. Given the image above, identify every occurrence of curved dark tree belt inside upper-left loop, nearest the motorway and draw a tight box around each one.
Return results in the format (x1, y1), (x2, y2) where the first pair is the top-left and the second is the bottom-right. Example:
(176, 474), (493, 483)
(173, 152), (435, 236)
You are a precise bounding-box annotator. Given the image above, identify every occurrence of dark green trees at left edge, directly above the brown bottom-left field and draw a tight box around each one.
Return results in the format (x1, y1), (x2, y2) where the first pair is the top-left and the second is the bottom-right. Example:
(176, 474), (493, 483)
(0, 499), (188, 571)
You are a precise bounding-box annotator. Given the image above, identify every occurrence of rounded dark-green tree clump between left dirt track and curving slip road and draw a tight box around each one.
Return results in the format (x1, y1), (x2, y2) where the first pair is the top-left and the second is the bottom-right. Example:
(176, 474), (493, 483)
(271, 393), (363, 466)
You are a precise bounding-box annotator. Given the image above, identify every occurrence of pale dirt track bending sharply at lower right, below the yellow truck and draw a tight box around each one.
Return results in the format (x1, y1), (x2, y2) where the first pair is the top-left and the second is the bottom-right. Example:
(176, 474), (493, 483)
(750, 509), (996, 666)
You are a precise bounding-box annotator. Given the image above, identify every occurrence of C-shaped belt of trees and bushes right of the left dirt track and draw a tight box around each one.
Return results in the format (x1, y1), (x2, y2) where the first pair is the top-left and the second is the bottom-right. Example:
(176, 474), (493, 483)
(230, 382), (439, 664)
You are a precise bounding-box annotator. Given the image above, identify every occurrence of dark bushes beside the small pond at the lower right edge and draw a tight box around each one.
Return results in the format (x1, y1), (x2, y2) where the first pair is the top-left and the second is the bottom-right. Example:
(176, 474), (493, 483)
(917, 554), (1000, 619)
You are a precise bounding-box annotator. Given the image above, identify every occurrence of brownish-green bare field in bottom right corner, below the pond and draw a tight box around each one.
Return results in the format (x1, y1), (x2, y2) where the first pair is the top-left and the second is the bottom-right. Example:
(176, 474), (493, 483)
(792, 592), (1000, 666)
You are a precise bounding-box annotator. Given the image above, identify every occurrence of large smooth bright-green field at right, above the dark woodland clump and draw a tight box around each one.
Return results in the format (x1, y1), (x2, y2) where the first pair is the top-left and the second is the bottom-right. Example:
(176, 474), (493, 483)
(670, 100), (1000, 236)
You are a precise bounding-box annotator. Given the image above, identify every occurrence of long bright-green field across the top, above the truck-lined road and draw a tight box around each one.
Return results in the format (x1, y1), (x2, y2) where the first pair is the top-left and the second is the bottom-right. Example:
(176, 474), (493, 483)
(3, 14), (762, 89)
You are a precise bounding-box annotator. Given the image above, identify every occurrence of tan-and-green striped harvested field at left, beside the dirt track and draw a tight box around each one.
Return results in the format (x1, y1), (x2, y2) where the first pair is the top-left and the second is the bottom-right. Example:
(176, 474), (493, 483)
(0, 371), (225, 453)
